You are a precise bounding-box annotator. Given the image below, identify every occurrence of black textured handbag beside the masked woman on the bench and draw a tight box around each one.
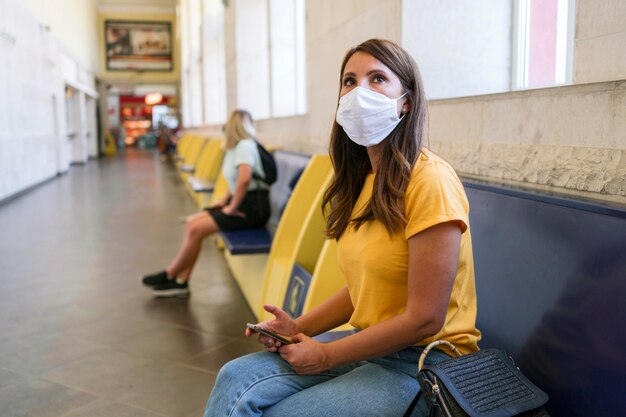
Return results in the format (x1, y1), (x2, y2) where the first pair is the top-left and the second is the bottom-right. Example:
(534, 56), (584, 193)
(404, 340), (549, 417)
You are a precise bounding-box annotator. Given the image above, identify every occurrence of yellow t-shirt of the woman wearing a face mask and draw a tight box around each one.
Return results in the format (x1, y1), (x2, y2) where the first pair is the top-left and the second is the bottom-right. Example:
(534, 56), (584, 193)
(337, 149), (480, 354)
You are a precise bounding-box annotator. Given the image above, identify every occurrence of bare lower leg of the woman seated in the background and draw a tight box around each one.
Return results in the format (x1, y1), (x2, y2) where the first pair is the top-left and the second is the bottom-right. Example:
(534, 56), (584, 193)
(165, 211), (219, 281)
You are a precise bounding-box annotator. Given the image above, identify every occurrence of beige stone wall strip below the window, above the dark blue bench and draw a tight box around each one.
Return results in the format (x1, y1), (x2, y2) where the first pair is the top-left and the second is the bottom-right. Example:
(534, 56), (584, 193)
(429, 81), (626, 198)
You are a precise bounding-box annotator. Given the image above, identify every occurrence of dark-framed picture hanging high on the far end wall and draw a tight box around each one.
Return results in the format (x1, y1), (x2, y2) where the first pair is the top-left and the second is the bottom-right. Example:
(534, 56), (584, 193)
(104, 20), (173, 71)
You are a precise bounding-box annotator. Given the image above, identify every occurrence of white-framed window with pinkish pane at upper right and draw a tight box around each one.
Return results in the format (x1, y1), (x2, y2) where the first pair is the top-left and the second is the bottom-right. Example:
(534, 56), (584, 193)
(513, 0), (574, 89)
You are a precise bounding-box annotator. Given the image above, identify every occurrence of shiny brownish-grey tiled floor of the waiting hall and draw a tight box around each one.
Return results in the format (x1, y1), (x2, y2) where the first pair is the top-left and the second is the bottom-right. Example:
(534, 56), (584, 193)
(0, 150), (258, 417)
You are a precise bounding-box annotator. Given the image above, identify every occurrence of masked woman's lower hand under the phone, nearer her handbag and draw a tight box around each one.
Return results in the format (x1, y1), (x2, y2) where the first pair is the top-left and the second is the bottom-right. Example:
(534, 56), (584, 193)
(278, 333), (333, 375)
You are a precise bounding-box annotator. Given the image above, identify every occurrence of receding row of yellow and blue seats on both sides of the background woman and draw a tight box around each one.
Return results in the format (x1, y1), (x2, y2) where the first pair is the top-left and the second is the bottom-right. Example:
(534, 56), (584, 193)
(177, 135), (352, 332)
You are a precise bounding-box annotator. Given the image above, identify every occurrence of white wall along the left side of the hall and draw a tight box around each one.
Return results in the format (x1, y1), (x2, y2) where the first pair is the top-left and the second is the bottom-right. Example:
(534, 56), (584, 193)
(0, 0), (96, 201)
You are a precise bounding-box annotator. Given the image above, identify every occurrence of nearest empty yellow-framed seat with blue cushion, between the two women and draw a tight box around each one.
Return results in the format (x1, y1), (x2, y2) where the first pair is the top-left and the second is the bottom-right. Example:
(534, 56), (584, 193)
(222, 151), (345, 330)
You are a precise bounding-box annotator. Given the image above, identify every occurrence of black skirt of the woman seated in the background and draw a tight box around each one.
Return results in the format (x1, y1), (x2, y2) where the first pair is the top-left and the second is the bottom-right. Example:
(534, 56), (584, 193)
(205, 190), (270, 231)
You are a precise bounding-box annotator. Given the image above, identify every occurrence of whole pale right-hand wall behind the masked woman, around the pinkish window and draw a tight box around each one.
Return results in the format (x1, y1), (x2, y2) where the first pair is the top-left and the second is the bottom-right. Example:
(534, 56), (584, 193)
(186, 0), (626, 202)
